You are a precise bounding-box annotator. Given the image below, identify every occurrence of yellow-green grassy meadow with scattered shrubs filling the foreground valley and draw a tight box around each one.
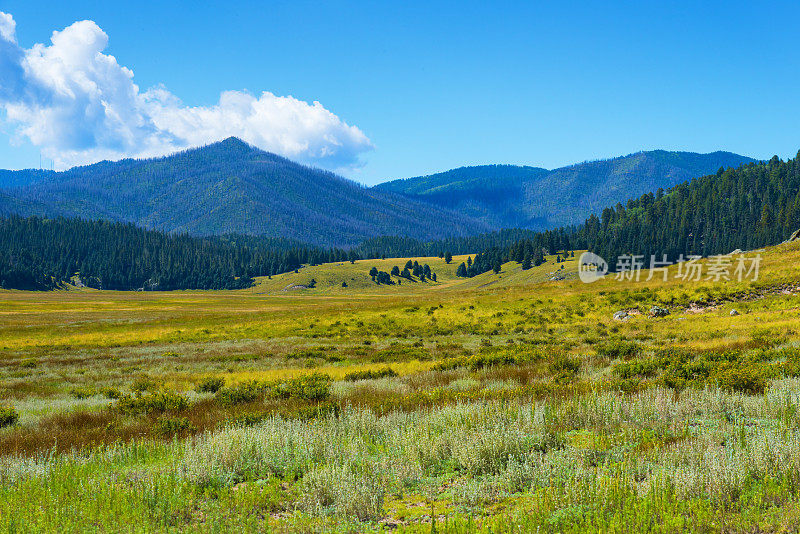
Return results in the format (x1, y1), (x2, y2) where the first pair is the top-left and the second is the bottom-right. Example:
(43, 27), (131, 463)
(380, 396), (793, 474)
(0, 244), (800, 532)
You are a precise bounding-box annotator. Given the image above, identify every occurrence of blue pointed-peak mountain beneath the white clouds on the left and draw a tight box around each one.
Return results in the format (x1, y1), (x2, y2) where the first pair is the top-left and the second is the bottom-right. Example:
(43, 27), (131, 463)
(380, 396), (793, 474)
(0, 138), (490, 246)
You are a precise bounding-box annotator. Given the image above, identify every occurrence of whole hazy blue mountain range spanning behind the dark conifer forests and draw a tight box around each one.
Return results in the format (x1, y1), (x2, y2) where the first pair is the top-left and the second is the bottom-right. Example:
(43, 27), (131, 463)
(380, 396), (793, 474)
(0, 138), (754, 247)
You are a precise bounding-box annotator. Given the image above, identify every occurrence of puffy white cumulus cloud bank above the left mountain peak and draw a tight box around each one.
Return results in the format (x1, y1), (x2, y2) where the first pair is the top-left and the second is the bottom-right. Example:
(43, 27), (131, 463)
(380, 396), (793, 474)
(0, 12), (372, 170)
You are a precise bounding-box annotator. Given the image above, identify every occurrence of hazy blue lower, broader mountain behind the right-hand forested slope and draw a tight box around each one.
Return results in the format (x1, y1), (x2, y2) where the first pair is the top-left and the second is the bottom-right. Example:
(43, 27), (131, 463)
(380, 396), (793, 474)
(375, 150), (755, 230)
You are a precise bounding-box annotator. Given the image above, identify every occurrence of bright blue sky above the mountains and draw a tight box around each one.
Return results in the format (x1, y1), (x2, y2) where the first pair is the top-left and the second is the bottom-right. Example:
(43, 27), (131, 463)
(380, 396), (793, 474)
(0, 0), (800, 184)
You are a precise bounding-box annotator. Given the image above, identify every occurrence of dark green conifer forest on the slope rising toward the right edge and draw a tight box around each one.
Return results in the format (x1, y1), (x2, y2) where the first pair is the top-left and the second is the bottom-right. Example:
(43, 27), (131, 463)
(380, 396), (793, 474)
(462, 152), (800, 275)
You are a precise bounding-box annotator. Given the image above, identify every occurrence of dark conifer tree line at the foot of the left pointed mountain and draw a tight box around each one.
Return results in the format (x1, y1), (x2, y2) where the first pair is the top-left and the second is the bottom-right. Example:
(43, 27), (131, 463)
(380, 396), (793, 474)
(0, 216), (356, 290)
